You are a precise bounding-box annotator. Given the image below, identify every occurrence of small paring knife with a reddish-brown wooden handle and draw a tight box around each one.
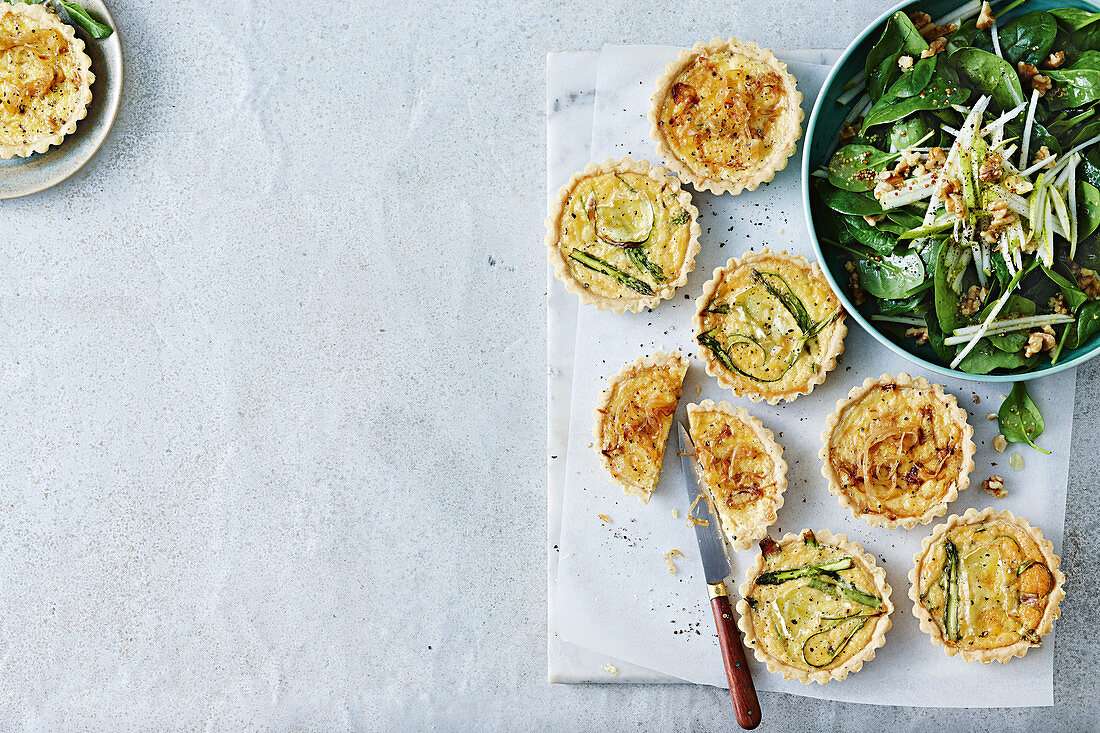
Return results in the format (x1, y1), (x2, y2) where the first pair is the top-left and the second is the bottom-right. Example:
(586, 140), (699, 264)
(677, 422), (760, 730)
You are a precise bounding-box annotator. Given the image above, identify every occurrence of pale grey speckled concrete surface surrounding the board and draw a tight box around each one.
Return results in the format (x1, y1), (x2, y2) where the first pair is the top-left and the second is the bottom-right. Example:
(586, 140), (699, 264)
(0, 0), (1100, 731)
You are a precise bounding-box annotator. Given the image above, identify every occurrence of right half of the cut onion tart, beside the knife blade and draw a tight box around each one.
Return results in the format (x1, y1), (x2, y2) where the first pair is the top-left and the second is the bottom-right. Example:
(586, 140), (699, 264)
(688, 400), (787, 550)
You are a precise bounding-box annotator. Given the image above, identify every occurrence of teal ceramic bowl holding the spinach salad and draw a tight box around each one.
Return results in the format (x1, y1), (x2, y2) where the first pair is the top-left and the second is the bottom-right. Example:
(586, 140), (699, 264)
(802, 0), (1100, 382)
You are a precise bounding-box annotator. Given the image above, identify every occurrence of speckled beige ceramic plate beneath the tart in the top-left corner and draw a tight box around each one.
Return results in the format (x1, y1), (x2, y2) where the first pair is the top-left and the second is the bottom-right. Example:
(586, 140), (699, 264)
(0, 0), (123, 199)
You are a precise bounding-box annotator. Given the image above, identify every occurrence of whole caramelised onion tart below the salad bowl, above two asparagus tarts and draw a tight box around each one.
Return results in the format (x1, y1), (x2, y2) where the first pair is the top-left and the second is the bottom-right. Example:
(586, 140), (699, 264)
(818, 372), (976, 529)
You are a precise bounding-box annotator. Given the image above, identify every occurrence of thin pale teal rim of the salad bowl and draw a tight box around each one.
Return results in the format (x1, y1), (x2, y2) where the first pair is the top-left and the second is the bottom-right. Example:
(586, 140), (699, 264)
(802, 0), (1100, 382)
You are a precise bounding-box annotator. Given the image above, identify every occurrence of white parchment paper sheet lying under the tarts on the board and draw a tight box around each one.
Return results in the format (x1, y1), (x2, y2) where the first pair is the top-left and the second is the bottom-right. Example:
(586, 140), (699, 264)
(551, 46), (1075, 707)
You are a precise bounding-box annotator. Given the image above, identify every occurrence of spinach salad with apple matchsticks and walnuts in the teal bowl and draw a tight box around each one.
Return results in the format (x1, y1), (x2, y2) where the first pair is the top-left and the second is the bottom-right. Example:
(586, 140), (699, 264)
(812, 0), (1100, 387)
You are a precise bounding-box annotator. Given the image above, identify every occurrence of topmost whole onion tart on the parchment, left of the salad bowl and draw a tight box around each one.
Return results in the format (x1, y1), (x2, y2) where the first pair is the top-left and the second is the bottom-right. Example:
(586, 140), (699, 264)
(649, 39), (803, 194)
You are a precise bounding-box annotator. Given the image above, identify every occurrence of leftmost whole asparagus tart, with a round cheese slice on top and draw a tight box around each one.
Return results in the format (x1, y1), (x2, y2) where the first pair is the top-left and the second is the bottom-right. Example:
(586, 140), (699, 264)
(546, 157), (700, 313)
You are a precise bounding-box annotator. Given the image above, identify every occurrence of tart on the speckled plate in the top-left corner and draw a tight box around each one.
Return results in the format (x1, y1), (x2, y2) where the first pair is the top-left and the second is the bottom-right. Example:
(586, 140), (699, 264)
(0, 2), (96, 160)
